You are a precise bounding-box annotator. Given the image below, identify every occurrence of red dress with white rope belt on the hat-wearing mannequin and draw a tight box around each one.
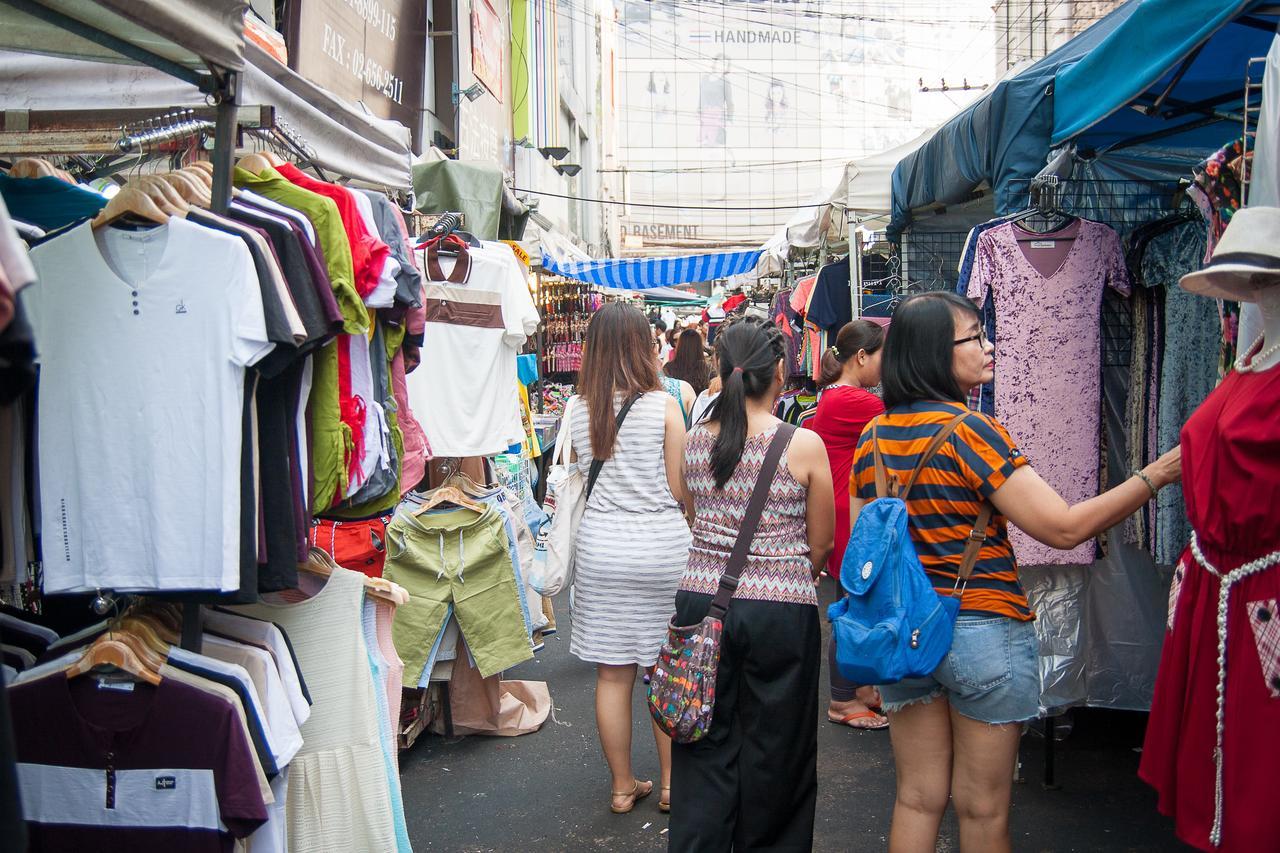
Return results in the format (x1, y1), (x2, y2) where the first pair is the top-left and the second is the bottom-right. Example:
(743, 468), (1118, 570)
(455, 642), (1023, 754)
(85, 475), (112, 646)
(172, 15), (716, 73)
(1138, 356), (1280, 852)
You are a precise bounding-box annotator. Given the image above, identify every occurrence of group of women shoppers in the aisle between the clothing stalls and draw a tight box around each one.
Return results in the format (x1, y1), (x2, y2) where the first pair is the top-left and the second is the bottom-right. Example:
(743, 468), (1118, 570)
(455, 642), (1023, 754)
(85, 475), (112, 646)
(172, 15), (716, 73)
(567, 292), (1181, 853)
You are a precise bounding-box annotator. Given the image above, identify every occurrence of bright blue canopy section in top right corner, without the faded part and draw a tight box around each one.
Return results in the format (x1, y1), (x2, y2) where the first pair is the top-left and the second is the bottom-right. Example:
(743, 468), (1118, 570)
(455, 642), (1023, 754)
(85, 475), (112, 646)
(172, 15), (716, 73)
(1052, 0), (1280, 154)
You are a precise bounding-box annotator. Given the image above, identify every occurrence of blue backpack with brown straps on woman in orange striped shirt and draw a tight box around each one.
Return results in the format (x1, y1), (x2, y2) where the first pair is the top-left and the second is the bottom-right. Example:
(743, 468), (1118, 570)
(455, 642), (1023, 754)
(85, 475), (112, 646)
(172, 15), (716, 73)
(827, 412), (992, 684)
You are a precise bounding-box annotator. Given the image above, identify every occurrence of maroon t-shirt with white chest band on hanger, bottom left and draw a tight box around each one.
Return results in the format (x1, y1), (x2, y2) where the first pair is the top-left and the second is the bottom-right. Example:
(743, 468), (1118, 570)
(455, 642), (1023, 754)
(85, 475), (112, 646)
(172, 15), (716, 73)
(9, 674), (266, 853)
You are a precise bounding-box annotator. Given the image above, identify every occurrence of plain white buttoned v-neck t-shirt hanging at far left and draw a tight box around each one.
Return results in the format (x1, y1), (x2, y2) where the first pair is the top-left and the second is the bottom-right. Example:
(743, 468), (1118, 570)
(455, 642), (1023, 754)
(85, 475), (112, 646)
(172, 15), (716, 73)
(22, 218), (274, 592)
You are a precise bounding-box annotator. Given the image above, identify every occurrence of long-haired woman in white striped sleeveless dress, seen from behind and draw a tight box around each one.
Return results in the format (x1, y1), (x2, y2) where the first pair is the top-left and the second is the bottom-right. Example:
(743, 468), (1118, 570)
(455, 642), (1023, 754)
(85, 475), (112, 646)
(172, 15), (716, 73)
(566, 304), (690, 815)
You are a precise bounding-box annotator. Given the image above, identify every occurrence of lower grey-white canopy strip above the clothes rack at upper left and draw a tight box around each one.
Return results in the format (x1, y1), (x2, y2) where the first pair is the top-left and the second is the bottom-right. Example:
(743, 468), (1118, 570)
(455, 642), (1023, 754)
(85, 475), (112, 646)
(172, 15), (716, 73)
(0, 41), (412, 190)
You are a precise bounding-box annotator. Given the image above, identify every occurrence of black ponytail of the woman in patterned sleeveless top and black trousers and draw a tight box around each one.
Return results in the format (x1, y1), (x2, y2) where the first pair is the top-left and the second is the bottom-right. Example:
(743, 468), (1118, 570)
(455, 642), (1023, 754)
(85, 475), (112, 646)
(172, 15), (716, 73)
(710, 316), (786, 489)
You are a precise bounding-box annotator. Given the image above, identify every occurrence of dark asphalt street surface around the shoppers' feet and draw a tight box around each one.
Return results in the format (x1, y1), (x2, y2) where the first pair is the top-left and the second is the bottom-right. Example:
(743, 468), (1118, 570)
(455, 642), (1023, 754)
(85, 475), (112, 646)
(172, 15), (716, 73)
(401, 592), (1190, 853)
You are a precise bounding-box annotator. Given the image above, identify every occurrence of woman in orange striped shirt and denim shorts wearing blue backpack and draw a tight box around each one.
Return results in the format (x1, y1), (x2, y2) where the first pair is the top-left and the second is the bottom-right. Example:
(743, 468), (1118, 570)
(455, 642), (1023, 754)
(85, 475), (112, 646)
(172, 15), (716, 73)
(832, 292), (1181, 853)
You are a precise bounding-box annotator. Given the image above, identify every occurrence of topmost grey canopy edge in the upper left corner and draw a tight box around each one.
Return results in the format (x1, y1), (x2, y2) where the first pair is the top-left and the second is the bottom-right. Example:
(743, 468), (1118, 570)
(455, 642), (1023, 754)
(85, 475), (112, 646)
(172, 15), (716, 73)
(0, 0), (248, 83)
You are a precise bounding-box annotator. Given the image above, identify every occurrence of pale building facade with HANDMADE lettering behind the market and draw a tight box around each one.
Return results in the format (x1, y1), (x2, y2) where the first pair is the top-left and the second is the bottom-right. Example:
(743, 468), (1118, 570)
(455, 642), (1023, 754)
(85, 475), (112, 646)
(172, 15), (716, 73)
(617, 0), (992, 255)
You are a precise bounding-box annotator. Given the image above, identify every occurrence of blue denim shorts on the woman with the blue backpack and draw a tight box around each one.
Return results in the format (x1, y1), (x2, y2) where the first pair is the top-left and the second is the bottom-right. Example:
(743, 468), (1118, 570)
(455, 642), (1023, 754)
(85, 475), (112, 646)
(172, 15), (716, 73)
(879, 613), (1039, 725)
